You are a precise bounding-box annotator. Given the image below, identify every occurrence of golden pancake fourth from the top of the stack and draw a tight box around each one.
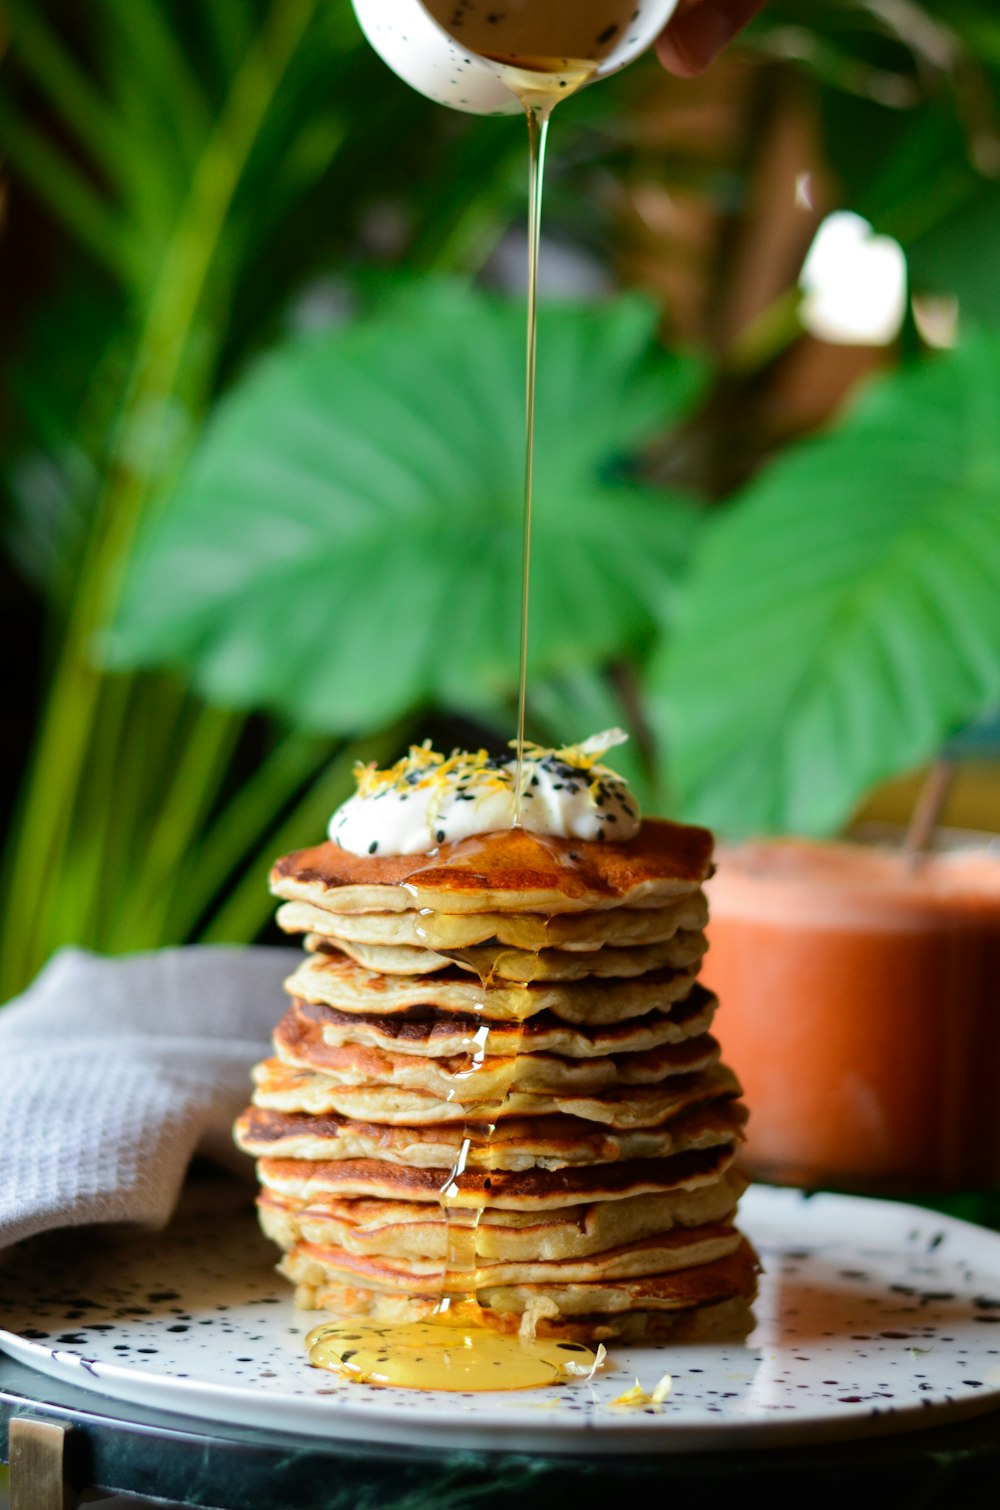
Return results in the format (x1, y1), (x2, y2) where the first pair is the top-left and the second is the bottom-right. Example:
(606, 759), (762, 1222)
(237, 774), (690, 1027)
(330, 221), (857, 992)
(285, 939), (695, 1025)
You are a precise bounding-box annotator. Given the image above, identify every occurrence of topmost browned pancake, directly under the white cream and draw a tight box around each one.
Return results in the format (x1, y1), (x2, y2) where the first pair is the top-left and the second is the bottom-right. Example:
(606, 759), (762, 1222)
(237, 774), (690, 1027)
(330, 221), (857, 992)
(270, 818), (713, 914)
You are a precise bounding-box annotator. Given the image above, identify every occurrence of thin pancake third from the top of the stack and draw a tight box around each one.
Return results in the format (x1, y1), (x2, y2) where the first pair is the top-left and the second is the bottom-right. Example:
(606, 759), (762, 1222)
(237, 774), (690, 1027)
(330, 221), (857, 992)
(317, 930), (708, 985)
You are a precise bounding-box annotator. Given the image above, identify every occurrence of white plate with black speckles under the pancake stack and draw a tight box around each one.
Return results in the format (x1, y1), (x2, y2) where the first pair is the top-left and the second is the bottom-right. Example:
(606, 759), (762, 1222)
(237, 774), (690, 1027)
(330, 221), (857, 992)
(0, 1181), (1000, 1453)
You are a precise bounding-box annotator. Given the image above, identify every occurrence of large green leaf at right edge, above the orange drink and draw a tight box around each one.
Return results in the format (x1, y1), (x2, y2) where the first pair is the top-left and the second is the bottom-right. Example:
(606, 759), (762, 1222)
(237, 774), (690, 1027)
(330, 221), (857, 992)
(651, 335), (1000, 835)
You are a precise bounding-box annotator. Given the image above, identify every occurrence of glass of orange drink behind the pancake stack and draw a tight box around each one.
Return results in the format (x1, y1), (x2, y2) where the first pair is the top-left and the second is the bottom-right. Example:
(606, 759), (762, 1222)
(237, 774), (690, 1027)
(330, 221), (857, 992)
(704, 840), (1000, 1191)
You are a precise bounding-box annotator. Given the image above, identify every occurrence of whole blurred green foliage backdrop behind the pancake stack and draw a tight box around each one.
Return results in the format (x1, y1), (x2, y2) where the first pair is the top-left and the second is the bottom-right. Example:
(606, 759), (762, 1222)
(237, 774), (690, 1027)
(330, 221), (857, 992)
(0, 0), (1000, 995)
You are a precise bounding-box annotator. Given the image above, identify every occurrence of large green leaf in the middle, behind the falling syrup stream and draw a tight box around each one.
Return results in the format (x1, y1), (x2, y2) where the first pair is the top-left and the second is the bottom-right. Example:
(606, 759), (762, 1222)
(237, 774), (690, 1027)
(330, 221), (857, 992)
(109, 284), (698, 732)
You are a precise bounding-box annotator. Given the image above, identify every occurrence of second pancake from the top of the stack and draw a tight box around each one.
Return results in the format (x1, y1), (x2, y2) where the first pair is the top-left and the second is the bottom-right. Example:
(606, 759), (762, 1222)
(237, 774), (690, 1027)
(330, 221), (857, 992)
(278, 891), (708, 951)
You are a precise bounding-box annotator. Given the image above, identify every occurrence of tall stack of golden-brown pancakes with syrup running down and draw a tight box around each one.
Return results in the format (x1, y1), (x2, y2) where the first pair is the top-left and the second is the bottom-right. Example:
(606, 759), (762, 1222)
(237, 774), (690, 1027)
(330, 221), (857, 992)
(236, 820), (757, 1341)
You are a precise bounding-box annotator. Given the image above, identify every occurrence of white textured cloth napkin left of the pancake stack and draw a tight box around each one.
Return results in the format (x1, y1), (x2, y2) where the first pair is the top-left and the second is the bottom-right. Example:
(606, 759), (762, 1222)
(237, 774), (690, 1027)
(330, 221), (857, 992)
(0, 945), (296, 1247)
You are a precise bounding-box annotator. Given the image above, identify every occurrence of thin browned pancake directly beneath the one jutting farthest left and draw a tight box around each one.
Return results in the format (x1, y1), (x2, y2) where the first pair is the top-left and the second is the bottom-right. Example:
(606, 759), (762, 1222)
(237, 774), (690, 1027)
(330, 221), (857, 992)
(257, 1143), (736, 1211)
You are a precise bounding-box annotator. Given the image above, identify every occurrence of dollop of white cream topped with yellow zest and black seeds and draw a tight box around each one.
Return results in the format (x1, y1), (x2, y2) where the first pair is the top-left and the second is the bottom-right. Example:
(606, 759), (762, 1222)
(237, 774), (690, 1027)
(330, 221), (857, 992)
(328, 729), (640, 855)
